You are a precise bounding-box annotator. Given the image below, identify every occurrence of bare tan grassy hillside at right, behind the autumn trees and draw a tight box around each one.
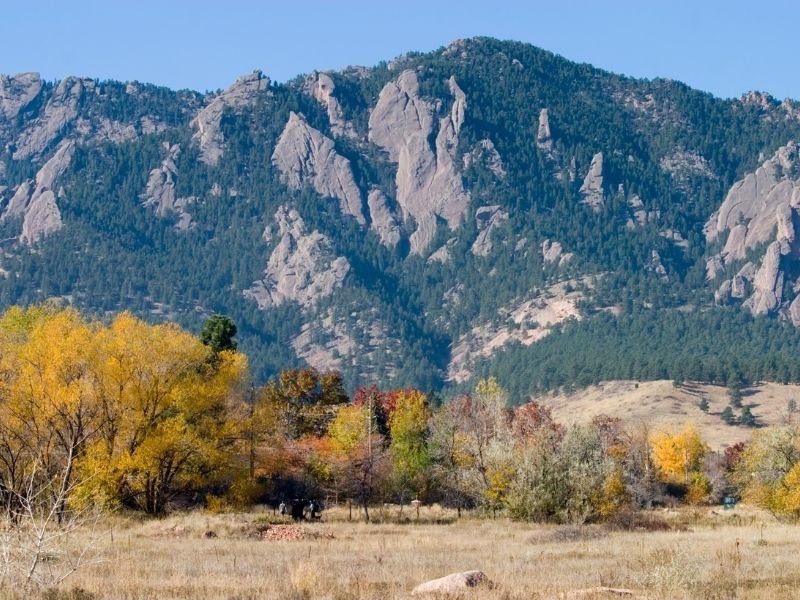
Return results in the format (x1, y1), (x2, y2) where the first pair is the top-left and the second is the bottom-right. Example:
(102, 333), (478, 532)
(537, 380), (800, 450)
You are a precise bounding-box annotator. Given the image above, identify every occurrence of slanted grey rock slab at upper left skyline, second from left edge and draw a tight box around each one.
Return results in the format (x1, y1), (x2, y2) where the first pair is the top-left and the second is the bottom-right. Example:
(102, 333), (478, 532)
(13, 77), (95, 160)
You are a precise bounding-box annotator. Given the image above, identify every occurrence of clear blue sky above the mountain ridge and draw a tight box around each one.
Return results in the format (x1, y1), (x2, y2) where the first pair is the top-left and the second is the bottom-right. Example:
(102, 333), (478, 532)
(0, 0), (800, 98)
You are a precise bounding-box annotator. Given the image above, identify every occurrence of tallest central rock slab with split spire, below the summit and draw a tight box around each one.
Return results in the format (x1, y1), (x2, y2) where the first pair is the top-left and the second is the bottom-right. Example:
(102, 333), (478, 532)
(369, 70), (469, 254)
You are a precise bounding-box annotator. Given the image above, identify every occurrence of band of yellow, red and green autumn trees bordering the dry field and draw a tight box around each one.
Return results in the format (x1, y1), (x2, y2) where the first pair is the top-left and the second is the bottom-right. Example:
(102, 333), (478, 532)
(0, 305), (800, 523)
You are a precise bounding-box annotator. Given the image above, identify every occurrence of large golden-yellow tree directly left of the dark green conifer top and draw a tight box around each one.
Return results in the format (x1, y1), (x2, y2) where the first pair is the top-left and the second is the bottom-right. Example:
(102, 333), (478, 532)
(82, 313), (247, 514)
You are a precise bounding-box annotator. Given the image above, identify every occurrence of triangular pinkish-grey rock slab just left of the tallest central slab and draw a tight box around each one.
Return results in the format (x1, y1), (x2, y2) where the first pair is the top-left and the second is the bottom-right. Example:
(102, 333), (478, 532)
(272, 112), (366, 225)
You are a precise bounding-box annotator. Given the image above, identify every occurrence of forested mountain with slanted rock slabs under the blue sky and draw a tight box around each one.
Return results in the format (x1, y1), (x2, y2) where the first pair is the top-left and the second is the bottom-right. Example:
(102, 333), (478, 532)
(0, 38), (800, 398)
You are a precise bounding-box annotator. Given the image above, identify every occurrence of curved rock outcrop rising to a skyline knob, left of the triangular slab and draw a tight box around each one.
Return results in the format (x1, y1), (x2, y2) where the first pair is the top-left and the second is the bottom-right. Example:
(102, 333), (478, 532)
(191, 71), (270, 165)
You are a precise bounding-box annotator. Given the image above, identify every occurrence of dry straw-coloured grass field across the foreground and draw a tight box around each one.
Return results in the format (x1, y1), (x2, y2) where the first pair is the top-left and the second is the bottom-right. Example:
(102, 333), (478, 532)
(10, 507), (800, 600)
